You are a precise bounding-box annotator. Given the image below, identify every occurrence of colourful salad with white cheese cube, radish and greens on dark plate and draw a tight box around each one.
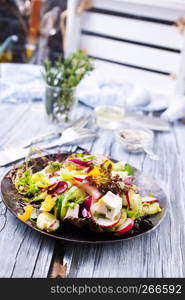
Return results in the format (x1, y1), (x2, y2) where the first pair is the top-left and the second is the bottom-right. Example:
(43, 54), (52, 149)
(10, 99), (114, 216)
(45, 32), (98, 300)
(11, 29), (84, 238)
(4, 152), (163, 237)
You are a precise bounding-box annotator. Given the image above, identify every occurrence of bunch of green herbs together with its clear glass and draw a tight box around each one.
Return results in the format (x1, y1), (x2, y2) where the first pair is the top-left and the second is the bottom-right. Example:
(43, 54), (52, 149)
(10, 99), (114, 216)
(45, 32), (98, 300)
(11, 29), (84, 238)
(43, 51), (93, 123)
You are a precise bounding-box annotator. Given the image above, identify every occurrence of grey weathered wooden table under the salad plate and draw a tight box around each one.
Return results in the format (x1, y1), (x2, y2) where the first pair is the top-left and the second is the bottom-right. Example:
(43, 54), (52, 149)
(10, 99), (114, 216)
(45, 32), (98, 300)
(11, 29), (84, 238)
(0, 103), (185, 278)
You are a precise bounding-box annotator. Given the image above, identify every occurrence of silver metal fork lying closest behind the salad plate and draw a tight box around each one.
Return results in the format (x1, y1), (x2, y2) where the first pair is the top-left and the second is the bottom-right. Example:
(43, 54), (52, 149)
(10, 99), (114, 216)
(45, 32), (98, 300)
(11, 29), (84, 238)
(0, 117), (97, 167)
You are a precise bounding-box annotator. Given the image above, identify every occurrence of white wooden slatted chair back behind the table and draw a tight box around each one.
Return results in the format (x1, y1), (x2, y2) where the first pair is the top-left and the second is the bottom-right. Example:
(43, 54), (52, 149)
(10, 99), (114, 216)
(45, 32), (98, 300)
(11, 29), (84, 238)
(65, 0), (185, 95)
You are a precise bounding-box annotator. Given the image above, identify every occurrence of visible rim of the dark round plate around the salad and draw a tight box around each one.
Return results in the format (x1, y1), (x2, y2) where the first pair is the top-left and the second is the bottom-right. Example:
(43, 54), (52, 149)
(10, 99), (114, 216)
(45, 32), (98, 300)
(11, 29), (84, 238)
(1, 153), (167, 243)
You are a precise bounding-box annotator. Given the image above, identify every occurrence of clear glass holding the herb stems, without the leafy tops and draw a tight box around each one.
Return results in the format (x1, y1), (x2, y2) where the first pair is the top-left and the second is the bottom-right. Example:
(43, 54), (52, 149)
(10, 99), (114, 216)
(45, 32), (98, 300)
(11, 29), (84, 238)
(45, 85), (76, 124)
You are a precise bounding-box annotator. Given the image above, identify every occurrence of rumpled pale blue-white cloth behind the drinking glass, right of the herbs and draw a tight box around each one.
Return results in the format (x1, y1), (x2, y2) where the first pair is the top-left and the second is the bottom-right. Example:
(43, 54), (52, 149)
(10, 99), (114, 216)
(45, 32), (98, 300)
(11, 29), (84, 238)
(77, 70), (185, 122)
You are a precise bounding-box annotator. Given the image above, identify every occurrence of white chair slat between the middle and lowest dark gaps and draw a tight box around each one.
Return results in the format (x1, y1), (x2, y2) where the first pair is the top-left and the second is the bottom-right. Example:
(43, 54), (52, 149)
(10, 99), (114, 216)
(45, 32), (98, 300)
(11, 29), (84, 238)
(80, 34), (180, 73)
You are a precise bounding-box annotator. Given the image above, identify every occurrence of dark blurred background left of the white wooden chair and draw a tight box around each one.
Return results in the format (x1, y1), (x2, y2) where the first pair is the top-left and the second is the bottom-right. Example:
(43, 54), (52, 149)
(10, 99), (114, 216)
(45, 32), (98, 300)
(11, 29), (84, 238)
(0, 0), (67, 63)
